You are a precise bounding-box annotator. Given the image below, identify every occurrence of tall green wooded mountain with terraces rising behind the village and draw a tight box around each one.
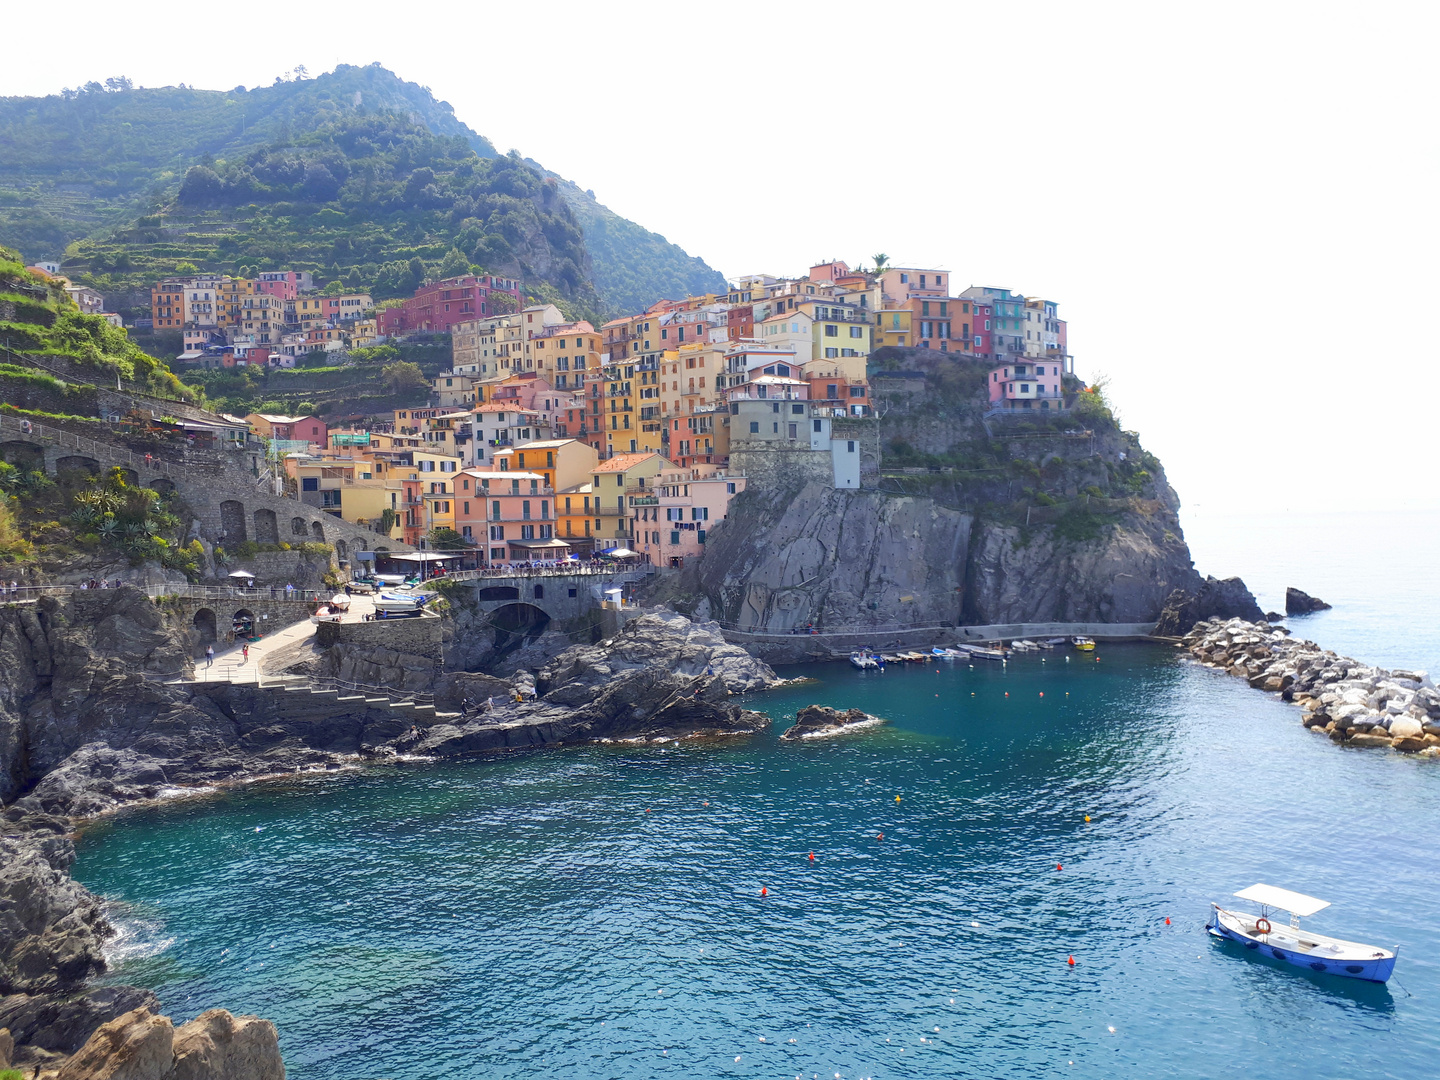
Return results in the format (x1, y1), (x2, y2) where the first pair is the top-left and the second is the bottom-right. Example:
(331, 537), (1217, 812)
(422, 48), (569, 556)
(0, 65), (724, 315)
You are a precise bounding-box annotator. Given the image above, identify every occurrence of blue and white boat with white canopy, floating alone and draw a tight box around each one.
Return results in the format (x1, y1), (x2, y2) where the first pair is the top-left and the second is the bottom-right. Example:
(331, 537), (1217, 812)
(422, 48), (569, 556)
(1205, 884), (1395, 982)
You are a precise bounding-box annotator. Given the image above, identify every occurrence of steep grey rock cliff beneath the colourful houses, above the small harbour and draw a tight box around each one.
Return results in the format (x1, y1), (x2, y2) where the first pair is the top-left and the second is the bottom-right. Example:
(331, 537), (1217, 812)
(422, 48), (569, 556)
(688, 354), (1253, 634)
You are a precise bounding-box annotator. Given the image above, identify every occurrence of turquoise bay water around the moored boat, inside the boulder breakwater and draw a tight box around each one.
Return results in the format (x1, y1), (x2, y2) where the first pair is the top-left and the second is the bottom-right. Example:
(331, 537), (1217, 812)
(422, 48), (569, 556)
(75, 645), (1440, 1080)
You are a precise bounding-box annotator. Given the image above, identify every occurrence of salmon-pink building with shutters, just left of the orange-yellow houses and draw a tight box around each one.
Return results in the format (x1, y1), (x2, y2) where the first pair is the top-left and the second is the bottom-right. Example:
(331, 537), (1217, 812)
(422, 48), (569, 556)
(455, 469), (570, 566)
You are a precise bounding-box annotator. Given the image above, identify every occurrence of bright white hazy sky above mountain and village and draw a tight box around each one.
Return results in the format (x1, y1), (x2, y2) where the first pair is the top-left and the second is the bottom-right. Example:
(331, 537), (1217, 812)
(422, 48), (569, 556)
(0, 0), (1440, 524)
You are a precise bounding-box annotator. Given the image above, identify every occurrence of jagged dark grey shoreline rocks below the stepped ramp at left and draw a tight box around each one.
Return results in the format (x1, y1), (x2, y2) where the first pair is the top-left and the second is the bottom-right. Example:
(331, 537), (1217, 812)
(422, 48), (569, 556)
(0, 588), (780, 1080)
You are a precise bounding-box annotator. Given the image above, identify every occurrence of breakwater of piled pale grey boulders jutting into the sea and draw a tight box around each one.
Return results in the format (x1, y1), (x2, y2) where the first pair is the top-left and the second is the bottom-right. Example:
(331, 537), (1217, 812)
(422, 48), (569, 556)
(1181, 619), (1440, 757)
